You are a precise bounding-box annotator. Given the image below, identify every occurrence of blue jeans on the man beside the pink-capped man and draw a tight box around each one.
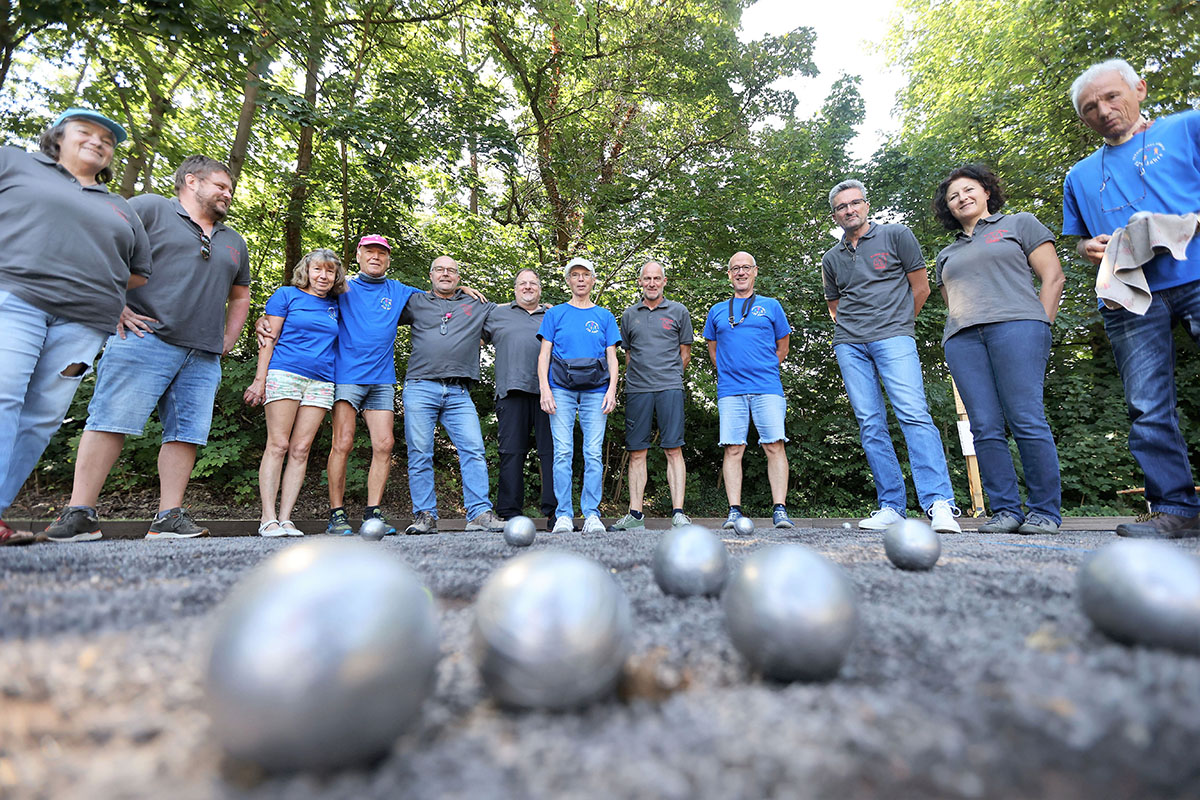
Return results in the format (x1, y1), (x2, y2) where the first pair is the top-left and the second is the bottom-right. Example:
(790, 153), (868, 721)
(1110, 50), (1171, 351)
(403, 380), (492, 519)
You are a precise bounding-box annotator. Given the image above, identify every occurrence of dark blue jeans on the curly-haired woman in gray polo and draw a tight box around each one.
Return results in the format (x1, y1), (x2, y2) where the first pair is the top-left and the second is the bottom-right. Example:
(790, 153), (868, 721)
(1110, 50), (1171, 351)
(944, 319), (1062, 522)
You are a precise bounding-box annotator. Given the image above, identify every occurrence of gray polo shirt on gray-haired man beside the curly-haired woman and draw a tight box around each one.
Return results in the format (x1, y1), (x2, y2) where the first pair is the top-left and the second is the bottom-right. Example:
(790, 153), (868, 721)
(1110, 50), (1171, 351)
(821, 222), (925, 344)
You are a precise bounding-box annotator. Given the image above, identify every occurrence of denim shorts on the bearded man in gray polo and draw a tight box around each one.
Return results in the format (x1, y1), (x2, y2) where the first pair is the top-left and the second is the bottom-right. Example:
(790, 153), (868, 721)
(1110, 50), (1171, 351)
(84, 333), (221, 445)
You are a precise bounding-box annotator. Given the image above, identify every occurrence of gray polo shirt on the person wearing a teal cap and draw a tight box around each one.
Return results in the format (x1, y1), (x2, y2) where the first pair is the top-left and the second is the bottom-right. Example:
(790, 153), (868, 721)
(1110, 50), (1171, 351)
(0, 148), (151, 333)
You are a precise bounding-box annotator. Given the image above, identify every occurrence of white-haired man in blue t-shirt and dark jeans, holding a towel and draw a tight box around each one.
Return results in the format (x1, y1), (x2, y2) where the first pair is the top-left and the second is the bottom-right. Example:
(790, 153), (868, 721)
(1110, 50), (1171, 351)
(1062, 59), (1200, 539)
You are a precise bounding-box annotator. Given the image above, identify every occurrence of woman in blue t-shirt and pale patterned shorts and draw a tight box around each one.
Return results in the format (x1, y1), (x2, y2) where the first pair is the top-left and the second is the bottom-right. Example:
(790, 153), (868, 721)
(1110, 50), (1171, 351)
(244, 249), (346, 536)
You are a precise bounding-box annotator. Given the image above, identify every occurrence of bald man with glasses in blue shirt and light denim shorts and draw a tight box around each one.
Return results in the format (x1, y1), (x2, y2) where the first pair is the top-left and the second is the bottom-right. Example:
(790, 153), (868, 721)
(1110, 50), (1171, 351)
(704, 252), (793, 528)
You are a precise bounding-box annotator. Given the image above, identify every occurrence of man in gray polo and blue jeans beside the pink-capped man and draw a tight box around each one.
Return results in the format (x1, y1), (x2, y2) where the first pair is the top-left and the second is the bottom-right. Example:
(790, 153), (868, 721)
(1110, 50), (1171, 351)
(400, 255), (504, 534)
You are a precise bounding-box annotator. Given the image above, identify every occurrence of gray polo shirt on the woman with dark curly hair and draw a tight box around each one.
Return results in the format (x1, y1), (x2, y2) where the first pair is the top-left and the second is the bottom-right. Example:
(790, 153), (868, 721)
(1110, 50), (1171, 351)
(936, 211), (1054, 344)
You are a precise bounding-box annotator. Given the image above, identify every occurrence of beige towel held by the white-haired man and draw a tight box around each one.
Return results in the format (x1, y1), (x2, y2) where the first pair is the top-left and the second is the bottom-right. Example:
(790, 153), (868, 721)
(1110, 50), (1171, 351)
(1096, 211), (1200, 315)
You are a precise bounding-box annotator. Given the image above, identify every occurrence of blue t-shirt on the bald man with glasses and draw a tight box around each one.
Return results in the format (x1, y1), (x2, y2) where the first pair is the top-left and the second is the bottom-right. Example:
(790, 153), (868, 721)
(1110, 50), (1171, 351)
(703, 296), (792, 397)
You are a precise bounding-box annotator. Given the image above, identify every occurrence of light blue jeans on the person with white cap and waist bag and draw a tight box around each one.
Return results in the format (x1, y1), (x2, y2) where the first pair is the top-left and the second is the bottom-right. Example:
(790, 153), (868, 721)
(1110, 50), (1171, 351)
(550, 386), (608, 518)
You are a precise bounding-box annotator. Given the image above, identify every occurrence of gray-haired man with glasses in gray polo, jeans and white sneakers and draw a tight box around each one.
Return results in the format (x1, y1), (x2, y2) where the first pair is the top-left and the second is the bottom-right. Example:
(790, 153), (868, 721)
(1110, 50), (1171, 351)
(821, 179), (962, 534)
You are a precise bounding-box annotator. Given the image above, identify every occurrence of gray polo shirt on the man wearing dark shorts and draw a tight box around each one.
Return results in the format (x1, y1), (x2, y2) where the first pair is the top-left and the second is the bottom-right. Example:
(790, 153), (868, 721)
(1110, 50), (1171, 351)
(620, 297), (692, 395)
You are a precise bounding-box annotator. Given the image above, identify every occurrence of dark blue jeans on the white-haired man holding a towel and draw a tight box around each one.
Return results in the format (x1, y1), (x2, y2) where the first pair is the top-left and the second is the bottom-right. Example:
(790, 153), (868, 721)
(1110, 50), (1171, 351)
(1100, 281), (1200, 517)
